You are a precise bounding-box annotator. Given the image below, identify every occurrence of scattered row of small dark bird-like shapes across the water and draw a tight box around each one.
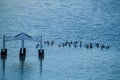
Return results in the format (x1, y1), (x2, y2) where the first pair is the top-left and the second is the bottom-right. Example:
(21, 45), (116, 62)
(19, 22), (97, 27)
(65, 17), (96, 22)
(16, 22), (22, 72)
(36, 40), (110, 50)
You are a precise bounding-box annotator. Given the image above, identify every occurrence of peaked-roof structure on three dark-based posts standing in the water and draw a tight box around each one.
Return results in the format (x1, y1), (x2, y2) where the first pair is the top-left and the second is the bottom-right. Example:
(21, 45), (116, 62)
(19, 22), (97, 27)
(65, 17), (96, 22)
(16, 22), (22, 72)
(1, 33), (44, 59)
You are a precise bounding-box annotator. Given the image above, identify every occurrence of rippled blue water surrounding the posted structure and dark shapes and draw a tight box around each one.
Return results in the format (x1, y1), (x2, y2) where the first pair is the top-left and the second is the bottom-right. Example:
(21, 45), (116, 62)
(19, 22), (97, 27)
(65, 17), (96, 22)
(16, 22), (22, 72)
(0, 0), (120, 80)
